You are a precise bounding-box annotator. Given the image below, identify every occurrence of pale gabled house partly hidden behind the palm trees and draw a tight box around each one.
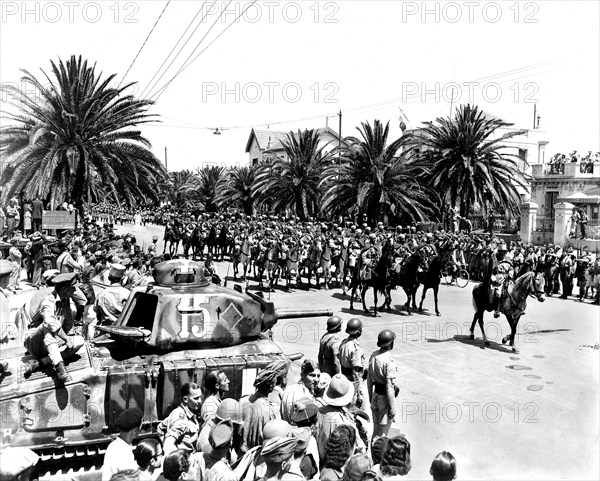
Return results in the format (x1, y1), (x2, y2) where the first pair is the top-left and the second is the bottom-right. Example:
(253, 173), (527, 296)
(246, 127), (345, 166)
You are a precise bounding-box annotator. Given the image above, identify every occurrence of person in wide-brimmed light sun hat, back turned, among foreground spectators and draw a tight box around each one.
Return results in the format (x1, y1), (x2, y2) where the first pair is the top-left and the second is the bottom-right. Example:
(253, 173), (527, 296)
(315, 374), (362, 463)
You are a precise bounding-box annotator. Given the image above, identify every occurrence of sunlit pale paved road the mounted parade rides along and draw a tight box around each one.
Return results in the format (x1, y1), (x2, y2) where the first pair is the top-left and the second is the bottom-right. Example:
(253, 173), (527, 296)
(118, 226), (600, 480)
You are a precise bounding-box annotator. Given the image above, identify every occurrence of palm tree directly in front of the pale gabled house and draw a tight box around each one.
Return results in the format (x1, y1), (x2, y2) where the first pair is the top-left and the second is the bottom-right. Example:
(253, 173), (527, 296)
(253, 129), (329, 219)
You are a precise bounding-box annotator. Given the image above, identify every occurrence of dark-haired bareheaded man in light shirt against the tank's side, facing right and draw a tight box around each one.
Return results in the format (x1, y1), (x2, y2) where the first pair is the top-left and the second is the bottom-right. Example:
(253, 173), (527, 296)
(157, 382), (202, 455)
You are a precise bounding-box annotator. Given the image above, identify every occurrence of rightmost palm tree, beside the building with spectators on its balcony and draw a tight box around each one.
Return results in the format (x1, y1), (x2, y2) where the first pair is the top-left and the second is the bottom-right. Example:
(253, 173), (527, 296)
(417, 105), (525, 217)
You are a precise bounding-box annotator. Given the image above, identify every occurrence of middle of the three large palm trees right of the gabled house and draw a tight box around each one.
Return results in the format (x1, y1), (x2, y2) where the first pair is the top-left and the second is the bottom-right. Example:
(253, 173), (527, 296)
(320, 120), (433, 222)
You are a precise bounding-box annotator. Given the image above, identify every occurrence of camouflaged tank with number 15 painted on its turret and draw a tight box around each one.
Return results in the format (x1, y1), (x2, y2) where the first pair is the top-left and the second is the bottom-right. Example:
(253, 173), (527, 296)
(0, 260), (332, 473)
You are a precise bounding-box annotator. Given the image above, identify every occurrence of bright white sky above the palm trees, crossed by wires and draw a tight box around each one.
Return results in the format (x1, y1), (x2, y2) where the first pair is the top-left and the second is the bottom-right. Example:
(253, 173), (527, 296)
(0, 0), (600, 171)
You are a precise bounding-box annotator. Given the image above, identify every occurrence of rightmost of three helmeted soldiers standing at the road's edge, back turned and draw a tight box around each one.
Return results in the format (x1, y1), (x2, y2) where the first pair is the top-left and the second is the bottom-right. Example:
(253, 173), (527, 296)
(367, 329), (398, 438)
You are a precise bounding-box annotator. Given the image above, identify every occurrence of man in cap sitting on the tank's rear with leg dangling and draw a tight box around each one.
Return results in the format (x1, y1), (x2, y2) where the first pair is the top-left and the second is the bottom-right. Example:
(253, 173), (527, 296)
(25, 272), (84, 382)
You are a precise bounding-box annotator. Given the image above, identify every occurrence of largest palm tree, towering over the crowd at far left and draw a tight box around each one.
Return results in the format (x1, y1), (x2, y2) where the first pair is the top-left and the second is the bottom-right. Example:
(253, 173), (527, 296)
(0, 56), (166, 213)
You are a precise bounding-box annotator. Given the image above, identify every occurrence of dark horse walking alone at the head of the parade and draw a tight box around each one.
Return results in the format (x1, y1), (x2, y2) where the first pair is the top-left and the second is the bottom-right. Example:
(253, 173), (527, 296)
(471, 272), (545, 353)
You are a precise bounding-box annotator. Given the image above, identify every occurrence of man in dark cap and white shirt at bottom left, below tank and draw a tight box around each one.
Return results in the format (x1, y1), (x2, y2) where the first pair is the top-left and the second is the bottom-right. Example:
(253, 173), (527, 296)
(102, 408), (143, 481)
